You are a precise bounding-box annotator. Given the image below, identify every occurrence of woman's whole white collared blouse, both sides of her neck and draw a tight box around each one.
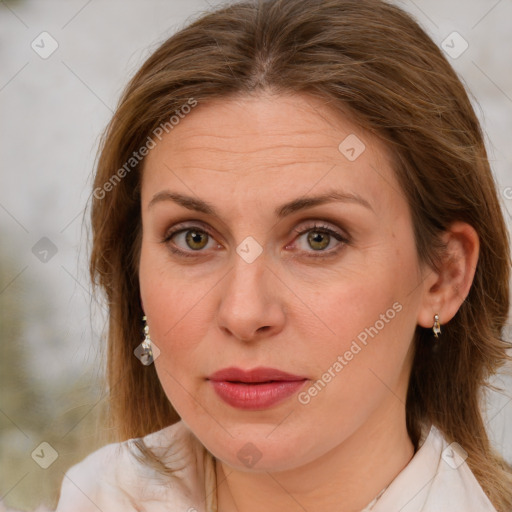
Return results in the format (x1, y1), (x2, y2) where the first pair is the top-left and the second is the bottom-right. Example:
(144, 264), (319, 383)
(56, 421), (496, 512)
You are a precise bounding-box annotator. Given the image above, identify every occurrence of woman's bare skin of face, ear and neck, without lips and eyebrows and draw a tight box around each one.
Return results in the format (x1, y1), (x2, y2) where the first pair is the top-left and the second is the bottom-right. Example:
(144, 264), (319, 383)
(139, 93), (478, 512)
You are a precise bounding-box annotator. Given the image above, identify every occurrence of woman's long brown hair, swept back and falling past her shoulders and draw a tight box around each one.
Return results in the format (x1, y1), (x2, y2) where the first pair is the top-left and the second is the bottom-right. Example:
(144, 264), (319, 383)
(90, 0), (512, 510)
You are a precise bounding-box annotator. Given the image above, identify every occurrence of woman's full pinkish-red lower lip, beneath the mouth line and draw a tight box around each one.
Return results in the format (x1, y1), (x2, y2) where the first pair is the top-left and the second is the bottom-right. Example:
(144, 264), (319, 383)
(210, 380), (306, 410)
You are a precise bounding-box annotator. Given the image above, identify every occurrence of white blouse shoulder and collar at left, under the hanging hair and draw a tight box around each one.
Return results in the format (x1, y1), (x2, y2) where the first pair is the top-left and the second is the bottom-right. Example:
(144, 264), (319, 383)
(56, 421), (211, 512)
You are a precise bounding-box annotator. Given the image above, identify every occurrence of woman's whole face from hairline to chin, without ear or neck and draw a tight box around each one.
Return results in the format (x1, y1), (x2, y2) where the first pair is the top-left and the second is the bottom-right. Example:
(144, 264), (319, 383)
(140, 94), (426, 470)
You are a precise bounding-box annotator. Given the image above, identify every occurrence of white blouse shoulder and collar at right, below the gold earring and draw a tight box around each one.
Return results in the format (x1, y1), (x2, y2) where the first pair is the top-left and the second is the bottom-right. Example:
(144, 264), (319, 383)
(373, 425), (496, 512)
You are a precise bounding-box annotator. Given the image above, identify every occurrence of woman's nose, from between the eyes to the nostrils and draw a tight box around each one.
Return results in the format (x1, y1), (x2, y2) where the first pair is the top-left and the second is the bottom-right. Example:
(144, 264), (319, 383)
(217, 247), (286, 342)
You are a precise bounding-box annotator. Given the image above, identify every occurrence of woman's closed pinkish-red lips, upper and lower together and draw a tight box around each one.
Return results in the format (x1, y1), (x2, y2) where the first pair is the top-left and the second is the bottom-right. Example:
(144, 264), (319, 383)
(207, 367), (308, 410)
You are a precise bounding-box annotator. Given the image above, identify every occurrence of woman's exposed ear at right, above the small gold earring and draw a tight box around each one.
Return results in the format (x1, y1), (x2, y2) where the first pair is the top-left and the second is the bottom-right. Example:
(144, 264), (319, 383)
(418, 222), (480, 328)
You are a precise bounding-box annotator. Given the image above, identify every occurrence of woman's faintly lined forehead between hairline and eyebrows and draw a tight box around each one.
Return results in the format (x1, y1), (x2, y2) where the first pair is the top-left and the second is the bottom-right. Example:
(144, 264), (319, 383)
(142, 94), (401, 218)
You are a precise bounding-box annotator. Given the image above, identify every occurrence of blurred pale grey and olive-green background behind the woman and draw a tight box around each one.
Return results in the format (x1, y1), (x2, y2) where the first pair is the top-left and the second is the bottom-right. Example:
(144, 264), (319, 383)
(0, 0), (512, 510)
